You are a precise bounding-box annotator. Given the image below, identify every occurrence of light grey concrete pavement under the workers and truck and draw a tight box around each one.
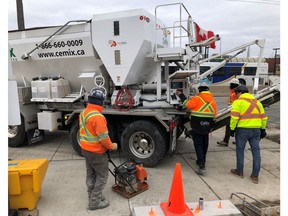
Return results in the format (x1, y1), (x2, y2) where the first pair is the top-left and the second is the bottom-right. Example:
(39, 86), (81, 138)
(8, 99), (280, 216)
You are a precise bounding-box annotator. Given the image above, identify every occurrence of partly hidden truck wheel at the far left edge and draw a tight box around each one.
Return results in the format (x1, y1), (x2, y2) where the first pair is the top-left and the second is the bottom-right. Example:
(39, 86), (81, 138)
(8, 115), (27, 147)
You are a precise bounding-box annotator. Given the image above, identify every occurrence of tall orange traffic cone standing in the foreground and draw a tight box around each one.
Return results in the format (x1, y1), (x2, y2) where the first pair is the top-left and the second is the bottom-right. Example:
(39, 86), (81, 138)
(160, 163), (194, 216)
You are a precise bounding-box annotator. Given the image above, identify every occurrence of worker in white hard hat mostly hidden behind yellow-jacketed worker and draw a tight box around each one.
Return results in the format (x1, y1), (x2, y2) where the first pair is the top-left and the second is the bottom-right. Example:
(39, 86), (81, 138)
(217, 78), (239, 146)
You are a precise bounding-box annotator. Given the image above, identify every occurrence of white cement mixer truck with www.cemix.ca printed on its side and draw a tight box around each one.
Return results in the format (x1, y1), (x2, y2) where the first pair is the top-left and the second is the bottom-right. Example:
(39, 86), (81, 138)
(8, 3), (276, 166)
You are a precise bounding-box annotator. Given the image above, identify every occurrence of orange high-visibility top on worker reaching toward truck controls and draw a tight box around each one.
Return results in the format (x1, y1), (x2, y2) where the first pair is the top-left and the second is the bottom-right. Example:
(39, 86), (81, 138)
(183, 91), (217, 118)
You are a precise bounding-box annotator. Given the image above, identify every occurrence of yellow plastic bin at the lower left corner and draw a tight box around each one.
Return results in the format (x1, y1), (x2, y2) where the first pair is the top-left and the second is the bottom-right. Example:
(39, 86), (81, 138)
(8, 158), (48, 210)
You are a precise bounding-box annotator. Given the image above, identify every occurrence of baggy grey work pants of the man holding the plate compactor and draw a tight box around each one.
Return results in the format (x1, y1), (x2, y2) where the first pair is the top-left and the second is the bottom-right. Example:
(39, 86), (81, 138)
(82, 150), (109, 206)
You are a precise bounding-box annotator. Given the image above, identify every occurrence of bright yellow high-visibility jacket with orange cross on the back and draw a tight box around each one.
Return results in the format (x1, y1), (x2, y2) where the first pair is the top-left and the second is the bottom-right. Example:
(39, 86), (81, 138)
(230, 93), (268, 130)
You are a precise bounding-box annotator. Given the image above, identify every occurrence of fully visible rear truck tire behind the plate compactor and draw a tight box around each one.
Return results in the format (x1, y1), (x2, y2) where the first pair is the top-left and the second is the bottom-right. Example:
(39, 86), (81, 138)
(121, 120), (166, 167)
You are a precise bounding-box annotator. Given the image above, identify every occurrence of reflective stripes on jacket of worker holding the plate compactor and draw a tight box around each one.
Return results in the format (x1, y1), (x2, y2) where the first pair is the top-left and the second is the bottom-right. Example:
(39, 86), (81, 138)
(79, 111), (108, 143)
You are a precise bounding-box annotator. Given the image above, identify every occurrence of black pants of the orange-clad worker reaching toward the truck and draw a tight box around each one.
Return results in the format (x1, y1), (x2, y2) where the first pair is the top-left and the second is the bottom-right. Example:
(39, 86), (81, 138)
(192, 131), (209, 166)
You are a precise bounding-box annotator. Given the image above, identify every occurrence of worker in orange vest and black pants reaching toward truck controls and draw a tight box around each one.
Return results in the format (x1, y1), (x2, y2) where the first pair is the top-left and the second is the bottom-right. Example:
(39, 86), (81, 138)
(176, 82), (217, 175)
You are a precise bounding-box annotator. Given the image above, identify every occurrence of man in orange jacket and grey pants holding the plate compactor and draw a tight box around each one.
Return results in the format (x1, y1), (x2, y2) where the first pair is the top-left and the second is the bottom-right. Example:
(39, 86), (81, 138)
(79, 89), (117, 210)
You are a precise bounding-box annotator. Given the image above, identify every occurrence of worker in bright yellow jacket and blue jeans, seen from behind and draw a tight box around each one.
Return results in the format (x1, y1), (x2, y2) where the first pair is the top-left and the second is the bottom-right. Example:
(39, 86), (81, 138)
(230, 85), (268, 184)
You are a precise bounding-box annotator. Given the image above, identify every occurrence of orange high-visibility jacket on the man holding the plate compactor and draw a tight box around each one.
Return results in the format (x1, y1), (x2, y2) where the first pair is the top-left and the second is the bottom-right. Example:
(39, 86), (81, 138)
(79, 104), (113, 154)
